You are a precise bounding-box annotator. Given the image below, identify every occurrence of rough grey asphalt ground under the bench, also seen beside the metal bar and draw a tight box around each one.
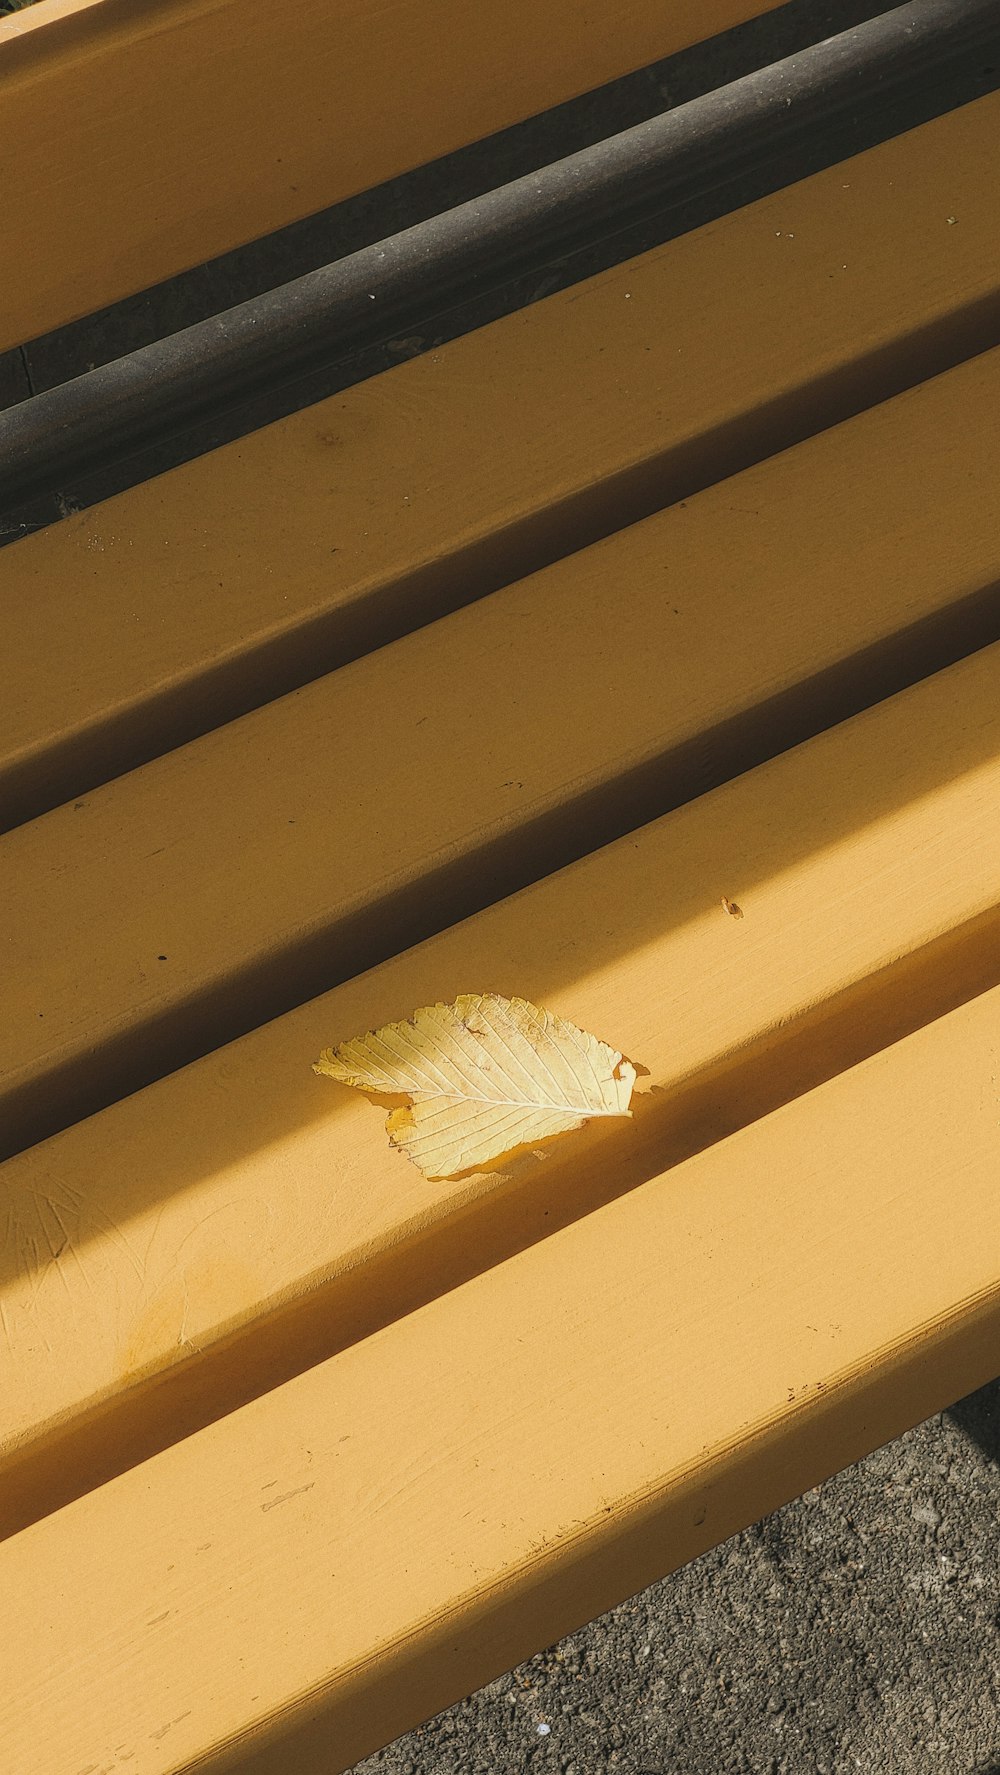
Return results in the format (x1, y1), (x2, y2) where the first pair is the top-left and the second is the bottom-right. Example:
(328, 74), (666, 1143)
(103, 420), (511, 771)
(0, 0), (1000, 1775)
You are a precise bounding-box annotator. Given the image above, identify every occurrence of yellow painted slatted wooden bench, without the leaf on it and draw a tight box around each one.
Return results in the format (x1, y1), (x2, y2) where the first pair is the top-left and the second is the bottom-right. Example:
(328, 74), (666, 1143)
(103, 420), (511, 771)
(0, 0), (1000, 1775)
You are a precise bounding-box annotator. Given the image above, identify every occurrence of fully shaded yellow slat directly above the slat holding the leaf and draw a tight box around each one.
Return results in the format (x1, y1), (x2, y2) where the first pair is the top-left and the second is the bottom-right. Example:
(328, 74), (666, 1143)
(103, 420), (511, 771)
(0, 351), (1000, 1152)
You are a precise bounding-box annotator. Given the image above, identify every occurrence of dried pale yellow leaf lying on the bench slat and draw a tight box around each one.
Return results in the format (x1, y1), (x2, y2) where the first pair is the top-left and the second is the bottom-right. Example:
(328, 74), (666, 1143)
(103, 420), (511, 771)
(313, 992), (636, 1177)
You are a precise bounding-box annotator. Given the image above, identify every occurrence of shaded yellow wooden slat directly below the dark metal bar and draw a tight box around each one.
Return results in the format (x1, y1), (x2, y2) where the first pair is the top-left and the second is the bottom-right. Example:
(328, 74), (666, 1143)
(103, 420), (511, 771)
(0, 88), (1000, 825)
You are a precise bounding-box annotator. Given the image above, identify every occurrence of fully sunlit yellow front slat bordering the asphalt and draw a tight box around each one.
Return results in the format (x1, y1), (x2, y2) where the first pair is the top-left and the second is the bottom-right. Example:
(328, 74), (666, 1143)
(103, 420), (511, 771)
(0, 990), (1000, 1775)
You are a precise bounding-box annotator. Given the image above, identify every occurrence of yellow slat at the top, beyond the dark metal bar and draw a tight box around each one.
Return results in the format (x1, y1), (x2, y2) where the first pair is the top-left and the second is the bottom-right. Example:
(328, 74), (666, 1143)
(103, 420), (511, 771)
(0, 0), (774, 350)
